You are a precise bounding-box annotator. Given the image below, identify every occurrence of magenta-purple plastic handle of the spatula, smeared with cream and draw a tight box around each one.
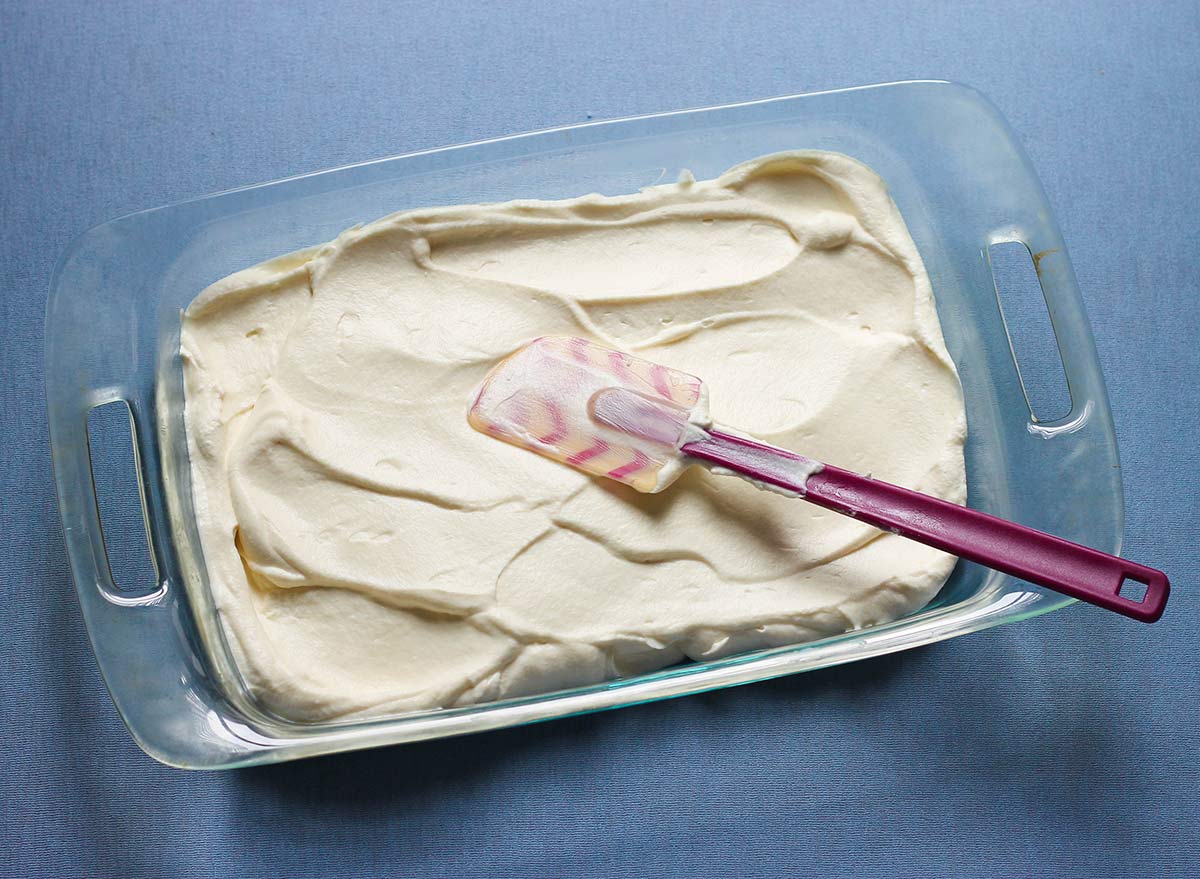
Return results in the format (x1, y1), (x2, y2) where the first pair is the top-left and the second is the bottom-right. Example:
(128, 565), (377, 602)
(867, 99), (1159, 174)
(682, 431), (1171, 622)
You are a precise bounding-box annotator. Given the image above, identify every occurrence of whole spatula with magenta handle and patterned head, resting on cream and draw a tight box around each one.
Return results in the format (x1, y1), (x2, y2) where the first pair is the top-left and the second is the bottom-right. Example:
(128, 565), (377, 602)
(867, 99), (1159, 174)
(468, 336), (1170, 622)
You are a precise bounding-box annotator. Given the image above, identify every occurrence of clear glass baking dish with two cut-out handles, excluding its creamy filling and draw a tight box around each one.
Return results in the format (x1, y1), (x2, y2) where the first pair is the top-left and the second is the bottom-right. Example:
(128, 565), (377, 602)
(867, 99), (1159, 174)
(46, 82), (1123, 769)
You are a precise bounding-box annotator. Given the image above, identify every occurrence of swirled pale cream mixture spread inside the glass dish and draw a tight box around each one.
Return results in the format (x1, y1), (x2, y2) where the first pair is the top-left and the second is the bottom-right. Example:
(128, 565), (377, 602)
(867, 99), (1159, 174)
(181, 151), (966, 719)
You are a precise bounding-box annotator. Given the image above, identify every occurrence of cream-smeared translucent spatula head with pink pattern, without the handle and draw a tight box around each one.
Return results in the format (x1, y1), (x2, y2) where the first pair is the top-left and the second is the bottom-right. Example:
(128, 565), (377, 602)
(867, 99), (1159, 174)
(467, 336), (708, 492)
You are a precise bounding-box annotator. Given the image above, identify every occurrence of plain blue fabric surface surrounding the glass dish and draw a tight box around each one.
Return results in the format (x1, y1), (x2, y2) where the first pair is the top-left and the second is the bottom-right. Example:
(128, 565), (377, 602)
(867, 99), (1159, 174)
(0, 0), (1200, 879)
